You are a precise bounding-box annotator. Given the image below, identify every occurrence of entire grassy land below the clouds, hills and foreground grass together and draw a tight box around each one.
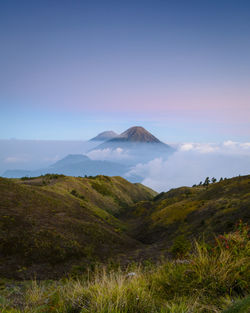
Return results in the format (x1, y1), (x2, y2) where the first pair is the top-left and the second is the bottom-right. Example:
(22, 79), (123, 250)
(0, 175), (250, 313)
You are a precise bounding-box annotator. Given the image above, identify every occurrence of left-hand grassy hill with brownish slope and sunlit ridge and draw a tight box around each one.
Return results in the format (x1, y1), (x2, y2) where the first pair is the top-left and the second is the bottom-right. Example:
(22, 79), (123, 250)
(0, 175), (156, 278)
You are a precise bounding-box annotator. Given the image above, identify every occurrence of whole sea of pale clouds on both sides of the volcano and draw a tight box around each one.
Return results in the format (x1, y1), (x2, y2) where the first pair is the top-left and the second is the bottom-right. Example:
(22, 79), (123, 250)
(0, 140), (250, 192)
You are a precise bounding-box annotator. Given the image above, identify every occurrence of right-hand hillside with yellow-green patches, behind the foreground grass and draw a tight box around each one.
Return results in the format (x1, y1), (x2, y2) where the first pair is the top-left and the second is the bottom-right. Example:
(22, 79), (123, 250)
(125, 175), (250, 251)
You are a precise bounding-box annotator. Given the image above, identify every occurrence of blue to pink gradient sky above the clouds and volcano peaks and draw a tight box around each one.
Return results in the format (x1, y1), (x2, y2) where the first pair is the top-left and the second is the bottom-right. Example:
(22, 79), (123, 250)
(0, 0), (250, 142)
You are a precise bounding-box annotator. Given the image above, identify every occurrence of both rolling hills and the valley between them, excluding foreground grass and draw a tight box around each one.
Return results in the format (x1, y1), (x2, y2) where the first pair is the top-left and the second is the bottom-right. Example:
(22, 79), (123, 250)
(0, 174), (250, 279)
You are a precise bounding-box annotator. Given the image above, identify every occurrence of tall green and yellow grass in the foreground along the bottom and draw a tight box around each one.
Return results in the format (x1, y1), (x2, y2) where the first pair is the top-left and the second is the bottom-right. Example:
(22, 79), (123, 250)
(0, 224), (250, 313)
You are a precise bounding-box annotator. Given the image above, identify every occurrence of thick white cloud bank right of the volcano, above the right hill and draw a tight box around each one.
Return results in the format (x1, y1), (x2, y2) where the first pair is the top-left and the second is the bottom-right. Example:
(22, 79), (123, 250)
(127, 141), (250, 191)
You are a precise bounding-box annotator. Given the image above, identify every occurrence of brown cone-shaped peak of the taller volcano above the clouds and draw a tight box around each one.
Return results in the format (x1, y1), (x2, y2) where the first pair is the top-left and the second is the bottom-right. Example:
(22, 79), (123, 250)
(110, 126), (161, 143)
